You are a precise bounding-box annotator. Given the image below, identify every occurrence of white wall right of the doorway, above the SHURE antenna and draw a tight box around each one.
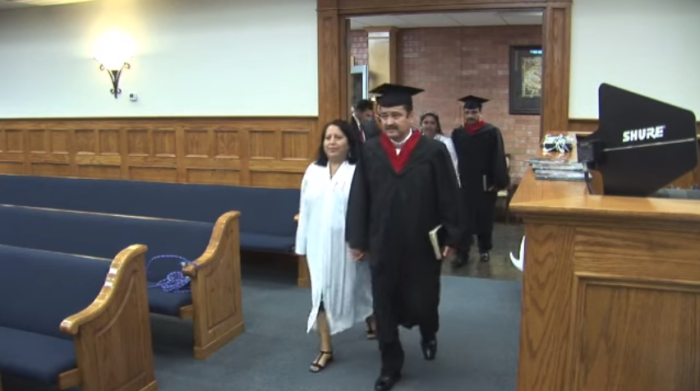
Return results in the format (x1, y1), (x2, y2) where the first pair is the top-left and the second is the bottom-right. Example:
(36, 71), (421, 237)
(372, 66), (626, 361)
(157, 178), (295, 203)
(569, 0), (700, 121)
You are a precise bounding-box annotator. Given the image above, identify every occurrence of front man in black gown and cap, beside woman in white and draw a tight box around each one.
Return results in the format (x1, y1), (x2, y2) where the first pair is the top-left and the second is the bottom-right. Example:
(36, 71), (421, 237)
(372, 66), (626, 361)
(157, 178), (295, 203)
(346, 84), (462, 391)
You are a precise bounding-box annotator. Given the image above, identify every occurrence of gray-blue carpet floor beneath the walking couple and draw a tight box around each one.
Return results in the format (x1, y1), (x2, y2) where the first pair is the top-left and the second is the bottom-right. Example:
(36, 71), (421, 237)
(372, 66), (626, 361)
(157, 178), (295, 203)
(3, 273), (521, 391)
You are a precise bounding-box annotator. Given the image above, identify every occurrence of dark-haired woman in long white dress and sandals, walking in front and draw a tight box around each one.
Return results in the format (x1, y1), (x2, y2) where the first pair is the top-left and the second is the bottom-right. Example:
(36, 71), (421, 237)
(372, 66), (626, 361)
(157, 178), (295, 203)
(296, 120), (374, 373)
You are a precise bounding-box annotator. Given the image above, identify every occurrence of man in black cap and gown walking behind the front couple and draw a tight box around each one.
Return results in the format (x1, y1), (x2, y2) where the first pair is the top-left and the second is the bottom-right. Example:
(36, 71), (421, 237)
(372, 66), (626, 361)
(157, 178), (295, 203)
(452, 95), (510, 267)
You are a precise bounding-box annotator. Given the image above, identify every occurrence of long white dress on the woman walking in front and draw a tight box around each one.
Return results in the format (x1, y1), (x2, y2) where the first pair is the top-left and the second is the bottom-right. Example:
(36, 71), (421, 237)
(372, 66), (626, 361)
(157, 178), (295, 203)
(295, 162), (373, 334)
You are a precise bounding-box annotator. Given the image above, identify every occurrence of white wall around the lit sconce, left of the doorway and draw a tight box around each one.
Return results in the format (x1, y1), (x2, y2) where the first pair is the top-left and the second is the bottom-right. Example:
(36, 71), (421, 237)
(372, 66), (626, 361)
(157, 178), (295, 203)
(0, 0), (318, 118)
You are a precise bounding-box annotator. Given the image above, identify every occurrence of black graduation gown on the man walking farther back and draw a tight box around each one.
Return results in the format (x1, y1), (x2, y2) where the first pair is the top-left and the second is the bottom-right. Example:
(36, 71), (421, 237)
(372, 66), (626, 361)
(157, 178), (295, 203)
(452, 123), (510, 235)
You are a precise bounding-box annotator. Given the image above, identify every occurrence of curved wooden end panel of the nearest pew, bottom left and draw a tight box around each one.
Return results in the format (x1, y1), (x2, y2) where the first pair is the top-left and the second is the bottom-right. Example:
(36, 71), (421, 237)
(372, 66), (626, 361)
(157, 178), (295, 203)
(60, 245), (157, 390)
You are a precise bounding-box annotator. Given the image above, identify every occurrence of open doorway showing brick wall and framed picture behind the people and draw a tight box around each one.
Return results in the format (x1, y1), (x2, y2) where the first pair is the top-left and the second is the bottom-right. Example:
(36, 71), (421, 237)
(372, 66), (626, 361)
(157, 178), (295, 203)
(346, 9), (544, 182)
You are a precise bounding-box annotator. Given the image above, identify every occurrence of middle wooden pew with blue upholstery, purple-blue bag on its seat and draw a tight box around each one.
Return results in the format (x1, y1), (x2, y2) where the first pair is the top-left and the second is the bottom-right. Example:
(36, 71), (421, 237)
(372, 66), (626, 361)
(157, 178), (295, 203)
(0, 205), (245, 359)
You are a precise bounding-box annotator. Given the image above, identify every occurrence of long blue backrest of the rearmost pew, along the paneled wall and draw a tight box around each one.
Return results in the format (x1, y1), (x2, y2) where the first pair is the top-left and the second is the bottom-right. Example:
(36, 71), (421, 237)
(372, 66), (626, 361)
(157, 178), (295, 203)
(0, 175), (300, 242)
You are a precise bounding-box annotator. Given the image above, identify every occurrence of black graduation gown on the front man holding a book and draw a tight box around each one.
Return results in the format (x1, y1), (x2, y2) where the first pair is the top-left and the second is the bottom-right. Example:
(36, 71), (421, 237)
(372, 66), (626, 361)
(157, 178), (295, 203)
(346, 137), (461, 340)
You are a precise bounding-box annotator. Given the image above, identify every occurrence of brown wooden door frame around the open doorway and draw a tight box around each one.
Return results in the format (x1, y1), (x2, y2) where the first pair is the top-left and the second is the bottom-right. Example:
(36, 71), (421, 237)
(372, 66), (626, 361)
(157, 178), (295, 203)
(316, 0), (572, 141)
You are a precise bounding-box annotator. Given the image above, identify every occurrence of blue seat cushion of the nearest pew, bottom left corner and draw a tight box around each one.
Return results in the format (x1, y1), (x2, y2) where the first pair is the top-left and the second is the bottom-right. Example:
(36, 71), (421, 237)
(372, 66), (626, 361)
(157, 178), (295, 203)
(0, 327), (77, 384)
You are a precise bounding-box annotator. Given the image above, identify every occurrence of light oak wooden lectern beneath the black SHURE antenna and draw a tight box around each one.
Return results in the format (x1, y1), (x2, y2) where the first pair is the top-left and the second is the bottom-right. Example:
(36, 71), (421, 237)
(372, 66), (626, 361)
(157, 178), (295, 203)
(510, 135), (700, 391)
